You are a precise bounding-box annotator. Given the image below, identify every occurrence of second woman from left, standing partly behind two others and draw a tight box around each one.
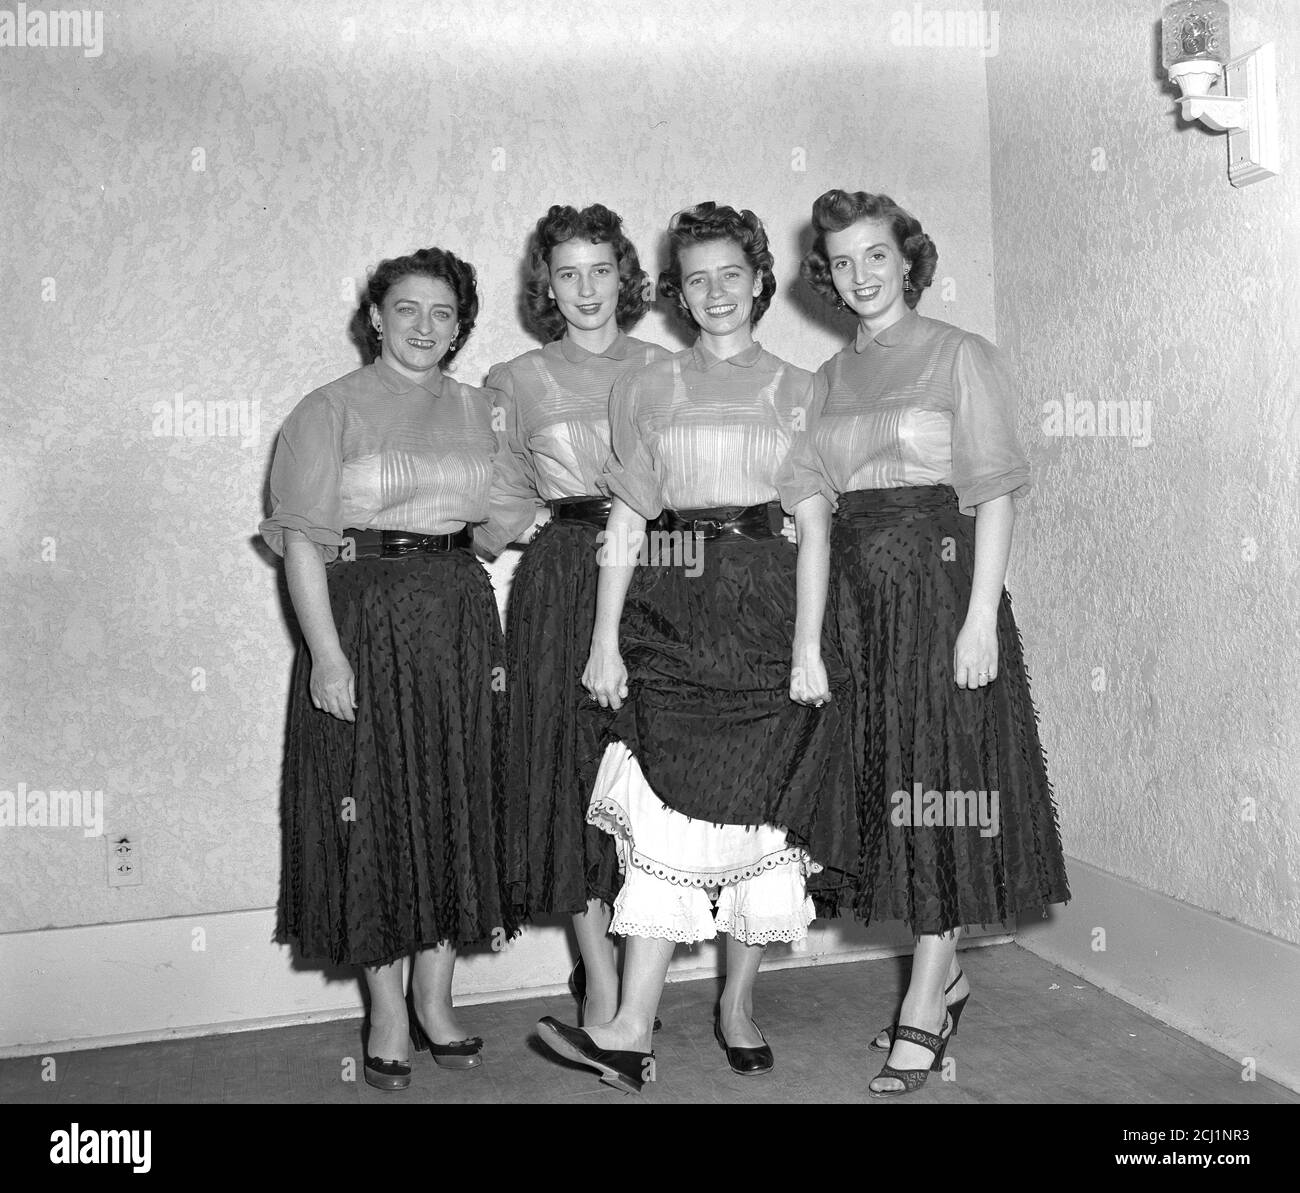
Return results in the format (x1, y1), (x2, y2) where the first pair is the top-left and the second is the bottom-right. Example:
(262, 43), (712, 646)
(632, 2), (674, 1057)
(475, 204), (668, 1023)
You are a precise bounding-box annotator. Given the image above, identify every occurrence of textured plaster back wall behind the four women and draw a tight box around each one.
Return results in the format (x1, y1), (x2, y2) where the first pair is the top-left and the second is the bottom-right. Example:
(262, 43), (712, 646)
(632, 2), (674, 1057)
(0, 0), (993, 930)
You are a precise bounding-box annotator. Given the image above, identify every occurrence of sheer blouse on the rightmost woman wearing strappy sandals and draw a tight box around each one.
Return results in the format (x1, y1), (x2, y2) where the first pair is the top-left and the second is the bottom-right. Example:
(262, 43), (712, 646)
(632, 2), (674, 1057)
(784, 311), (1030, 513)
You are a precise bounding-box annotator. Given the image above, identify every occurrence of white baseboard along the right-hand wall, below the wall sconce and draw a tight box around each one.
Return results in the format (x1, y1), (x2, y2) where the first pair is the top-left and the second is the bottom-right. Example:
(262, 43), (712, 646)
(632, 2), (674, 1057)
(1015, 859), (1300, 1090)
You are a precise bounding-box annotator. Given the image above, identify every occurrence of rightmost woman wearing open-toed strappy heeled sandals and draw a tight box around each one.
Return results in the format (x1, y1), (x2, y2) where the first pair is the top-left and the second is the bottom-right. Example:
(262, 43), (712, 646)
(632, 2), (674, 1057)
(789, 190), (1070, 1097)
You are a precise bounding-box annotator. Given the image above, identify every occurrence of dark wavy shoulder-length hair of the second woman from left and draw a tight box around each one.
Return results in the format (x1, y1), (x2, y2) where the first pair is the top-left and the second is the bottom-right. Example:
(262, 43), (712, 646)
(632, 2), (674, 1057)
(524, 203), (646, 343)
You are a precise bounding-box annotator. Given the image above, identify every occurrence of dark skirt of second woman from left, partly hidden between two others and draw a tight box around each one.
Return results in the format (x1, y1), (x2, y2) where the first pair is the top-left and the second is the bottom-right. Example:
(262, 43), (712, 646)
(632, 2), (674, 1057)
(504, 519), (623, 916)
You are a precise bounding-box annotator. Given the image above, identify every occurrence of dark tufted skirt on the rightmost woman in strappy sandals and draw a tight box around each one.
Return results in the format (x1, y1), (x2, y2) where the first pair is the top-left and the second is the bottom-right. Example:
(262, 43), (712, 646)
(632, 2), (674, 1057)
(827, 485), (1070, 933)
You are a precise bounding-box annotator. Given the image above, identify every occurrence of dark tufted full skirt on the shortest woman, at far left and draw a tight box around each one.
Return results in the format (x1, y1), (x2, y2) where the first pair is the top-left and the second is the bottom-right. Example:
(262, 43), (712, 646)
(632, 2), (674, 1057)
(276, 550), (516, 966)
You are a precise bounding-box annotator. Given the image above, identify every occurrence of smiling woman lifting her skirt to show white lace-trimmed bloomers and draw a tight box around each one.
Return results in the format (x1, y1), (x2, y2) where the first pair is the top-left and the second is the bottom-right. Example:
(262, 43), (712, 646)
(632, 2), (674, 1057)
(540, 203), (858, 1092)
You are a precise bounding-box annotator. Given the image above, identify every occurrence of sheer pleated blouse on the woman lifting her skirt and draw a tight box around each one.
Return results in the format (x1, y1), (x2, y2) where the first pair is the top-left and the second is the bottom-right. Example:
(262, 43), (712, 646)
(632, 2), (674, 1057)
(601, 343), (813, 519)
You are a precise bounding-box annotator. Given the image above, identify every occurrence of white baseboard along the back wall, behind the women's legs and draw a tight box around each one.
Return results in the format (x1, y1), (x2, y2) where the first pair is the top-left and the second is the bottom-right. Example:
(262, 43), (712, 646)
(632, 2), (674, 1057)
(0, 910), (1010, 1057)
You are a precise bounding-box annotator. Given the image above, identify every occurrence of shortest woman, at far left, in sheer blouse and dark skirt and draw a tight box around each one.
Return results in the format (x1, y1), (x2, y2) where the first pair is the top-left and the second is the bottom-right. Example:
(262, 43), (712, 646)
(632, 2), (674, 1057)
(261, 248), (515, 1089)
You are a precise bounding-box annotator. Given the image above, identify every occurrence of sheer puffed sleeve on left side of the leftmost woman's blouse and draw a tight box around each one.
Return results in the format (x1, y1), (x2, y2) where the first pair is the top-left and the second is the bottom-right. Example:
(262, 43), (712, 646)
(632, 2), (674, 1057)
(259, 391), (343, 563)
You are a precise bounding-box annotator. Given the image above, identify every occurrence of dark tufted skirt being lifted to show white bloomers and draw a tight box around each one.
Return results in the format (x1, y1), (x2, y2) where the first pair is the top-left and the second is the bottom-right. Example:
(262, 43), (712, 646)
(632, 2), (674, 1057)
(607, 522), (861, 914)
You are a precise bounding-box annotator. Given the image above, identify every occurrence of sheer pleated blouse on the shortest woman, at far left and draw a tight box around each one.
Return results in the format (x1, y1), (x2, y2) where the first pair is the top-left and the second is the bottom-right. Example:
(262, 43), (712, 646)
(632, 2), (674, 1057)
(260, 359), (497, 561)
